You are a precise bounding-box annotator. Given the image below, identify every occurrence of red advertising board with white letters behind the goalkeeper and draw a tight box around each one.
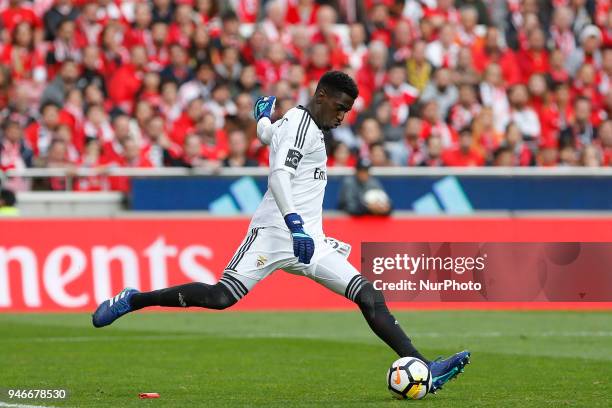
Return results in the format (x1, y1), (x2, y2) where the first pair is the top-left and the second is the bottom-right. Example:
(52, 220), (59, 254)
(0, 217), (612, 311)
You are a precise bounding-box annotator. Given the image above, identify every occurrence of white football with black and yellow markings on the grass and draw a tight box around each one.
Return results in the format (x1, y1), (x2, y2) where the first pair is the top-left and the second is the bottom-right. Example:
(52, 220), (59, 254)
(387, 357), (431, 399)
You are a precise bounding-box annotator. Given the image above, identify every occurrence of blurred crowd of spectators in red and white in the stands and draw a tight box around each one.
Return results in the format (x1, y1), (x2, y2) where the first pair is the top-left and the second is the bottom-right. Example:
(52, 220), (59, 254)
(0, 0), (612, 191)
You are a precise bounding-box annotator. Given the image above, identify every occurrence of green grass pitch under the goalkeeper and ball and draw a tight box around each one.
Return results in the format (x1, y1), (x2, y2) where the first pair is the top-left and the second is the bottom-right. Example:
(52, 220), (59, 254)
(0, 311), (612, 408)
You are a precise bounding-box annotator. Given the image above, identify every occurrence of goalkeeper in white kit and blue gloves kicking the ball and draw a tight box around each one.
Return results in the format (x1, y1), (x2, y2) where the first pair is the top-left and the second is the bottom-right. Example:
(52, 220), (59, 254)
(93, 71), (470, 392)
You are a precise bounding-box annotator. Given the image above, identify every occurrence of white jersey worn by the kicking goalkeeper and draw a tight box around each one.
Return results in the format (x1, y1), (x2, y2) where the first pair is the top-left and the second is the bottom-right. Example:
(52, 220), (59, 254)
(249, 106), (327, 238)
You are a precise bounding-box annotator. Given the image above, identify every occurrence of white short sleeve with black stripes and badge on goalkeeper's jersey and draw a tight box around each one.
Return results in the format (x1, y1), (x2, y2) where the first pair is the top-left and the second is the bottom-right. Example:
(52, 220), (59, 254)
(270, 110), (311, 174)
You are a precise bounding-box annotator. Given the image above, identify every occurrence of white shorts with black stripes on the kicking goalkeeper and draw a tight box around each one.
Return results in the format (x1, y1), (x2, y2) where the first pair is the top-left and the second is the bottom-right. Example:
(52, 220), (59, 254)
(220, 227), (367, 301)
